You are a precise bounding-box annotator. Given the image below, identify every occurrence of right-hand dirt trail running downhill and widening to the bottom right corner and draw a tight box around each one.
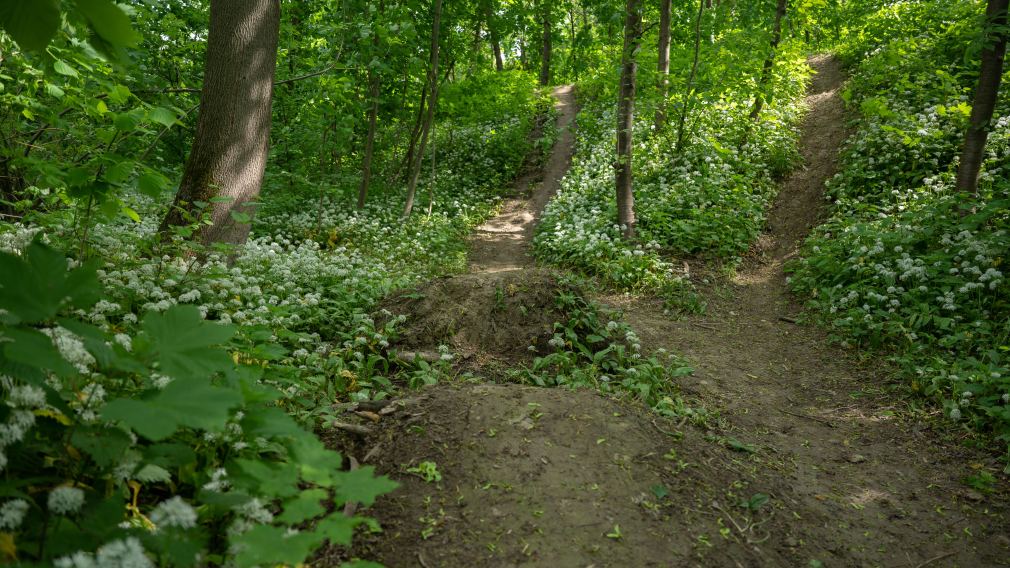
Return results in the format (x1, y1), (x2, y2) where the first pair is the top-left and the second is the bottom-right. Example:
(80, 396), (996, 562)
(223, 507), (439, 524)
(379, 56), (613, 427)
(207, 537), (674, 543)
(614, 53), (1010, 567)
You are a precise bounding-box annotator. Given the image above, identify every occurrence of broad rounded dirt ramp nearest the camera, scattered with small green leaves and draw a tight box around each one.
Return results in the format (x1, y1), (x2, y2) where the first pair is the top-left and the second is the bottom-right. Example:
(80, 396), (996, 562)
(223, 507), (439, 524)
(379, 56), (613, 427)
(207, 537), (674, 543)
(341, 384), (791, 568)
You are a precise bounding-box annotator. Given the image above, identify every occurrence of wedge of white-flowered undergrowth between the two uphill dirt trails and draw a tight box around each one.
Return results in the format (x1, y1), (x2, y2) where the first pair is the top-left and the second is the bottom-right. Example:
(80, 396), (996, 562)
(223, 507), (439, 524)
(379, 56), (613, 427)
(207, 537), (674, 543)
(533, 37), (809, 311)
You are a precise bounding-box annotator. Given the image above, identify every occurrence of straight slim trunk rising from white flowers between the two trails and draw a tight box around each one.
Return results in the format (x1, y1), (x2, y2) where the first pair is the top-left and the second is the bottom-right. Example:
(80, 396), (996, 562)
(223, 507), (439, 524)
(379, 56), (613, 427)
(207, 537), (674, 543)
(614, 0), (641, 239)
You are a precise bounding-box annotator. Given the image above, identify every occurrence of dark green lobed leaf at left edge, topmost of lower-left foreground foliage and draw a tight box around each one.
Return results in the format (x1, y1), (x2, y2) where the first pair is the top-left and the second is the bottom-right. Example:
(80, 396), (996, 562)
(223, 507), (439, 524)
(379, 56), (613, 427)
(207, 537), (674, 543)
(0, 242), (101, 323)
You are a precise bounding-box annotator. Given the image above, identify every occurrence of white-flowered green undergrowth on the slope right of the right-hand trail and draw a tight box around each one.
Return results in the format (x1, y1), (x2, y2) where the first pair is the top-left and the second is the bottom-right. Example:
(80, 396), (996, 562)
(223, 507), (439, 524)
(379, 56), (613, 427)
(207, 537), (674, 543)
(792, 2), (1010, 464)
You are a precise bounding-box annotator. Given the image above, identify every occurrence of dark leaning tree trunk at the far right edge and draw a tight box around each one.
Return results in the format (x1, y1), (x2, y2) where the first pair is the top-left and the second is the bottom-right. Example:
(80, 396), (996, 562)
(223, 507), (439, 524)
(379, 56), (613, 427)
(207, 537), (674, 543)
(956, 0), (1008, 201)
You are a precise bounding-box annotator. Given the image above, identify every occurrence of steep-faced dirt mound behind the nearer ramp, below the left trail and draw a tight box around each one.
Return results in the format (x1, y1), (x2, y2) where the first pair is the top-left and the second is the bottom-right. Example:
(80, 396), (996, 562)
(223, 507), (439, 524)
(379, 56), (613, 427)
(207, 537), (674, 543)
(380, 270), (578, 363)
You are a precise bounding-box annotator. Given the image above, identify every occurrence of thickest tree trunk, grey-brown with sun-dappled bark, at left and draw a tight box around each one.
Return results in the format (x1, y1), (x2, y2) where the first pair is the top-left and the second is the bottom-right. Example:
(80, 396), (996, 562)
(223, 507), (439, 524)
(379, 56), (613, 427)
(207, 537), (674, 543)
(162, 0), (281, 244)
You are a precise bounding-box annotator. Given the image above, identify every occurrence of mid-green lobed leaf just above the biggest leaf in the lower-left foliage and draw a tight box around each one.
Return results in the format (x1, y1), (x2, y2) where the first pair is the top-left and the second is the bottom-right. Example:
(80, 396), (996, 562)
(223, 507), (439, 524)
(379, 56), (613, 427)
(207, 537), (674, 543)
(142, 305), (235, 377)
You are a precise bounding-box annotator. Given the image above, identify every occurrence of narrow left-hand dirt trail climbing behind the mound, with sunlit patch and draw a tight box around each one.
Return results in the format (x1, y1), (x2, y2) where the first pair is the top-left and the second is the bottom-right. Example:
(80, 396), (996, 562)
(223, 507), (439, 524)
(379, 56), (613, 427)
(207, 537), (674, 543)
(470, 85), (577, 273)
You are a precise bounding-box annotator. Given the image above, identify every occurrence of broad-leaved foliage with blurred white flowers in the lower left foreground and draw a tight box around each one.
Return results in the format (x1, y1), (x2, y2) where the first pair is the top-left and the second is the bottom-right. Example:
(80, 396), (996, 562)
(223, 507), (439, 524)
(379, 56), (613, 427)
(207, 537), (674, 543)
(0, 243), (396, 566)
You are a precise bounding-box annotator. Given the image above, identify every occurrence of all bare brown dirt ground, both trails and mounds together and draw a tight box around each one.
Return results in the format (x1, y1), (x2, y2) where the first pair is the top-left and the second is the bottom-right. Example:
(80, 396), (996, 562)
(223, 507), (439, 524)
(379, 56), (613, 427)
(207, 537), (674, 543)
(319, 58), (1010, 568)
